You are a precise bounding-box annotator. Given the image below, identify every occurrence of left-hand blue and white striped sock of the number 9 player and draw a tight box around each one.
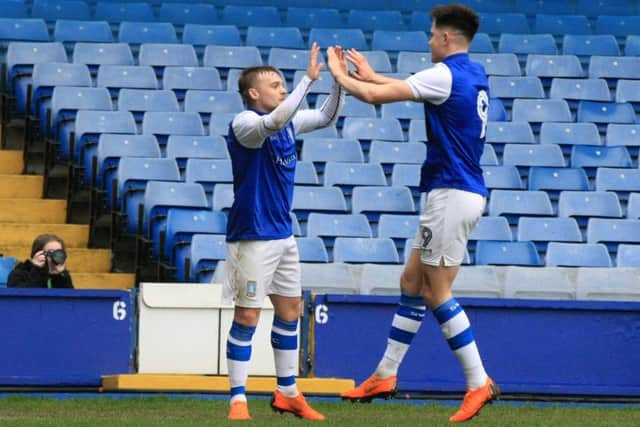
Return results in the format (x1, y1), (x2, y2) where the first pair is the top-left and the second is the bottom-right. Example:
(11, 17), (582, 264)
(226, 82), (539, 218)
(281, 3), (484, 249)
(375, 293), (427, 378)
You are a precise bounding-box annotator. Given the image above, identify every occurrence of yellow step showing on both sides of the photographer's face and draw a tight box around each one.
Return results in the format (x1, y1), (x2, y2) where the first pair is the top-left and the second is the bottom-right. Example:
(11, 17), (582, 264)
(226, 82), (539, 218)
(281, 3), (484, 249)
(0, 246), (111, 274)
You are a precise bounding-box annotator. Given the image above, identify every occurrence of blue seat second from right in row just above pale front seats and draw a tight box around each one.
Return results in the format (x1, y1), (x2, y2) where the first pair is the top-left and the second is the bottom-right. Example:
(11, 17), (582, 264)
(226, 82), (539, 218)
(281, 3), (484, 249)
(545, 242), (612, 267)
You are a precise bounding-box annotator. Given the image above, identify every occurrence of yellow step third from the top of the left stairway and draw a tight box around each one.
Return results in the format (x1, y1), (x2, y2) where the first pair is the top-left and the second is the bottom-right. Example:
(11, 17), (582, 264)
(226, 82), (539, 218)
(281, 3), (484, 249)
(0, 199), (67, 224)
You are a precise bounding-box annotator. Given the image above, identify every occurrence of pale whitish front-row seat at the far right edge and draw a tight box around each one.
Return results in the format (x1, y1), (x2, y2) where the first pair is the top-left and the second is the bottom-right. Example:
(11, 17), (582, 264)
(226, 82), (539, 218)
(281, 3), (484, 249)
(576, 265), (640, 301)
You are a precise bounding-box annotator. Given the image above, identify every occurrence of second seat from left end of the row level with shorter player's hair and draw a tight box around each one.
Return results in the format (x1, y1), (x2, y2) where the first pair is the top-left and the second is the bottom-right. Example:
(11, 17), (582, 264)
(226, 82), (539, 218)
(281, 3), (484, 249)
(96, 65), (158, 98)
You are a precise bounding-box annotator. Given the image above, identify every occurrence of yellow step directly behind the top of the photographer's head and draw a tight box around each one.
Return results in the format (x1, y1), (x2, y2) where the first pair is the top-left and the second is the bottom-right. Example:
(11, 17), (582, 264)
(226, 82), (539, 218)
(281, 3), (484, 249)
(0, 223), (89, 248)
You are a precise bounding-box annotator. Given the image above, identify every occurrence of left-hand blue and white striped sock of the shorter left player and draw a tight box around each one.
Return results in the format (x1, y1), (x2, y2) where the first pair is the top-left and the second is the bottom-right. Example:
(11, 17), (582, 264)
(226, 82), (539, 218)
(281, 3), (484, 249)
(227, 321), (256, 403)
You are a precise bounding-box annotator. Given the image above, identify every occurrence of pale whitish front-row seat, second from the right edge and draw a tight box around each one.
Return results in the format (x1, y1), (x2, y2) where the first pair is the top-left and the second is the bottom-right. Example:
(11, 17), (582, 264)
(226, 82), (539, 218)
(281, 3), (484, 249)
(504, 267), (576, 301)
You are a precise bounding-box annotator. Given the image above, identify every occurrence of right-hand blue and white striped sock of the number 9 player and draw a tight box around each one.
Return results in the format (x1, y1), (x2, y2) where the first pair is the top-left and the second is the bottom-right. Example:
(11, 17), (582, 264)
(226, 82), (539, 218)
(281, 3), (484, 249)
(433, 298), (487, 389)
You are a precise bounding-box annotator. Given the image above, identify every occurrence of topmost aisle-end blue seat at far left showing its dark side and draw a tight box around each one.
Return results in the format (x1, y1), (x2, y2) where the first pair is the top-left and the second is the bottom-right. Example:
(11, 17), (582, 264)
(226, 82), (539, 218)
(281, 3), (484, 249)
(6, 42), (68, 114)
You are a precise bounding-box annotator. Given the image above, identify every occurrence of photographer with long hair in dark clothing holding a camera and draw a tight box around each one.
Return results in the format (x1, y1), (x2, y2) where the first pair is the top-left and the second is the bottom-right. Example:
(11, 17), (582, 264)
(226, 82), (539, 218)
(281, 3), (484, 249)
(7, 234), (73, 289)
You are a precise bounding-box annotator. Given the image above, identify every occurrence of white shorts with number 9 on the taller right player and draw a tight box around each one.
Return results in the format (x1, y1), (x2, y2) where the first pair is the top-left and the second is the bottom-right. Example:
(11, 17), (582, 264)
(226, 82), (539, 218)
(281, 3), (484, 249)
(413, 188), (486, 267)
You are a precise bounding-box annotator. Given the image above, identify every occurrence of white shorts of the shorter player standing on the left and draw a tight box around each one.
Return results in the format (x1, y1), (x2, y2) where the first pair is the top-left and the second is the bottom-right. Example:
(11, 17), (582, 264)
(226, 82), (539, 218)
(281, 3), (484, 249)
(227, 236), (302, 308)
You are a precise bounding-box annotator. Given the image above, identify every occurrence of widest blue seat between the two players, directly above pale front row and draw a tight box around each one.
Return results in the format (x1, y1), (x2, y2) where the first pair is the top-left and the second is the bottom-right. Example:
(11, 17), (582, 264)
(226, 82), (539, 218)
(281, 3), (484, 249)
(333, 237), (400, 264)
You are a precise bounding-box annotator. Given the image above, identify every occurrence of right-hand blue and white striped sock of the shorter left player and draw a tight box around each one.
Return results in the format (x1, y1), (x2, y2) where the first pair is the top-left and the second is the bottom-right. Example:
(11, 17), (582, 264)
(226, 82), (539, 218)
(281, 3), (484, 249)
(271, 316), (298, 397)
